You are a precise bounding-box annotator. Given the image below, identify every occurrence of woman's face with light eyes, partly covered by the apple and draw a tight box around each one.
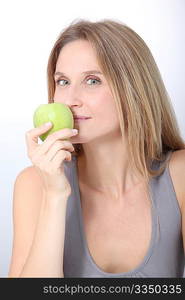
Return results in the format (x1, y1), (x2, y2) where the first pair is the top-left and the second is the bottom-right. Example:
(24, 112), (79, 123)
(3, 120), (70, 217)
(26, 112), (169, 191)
(54, 40), (121, 143)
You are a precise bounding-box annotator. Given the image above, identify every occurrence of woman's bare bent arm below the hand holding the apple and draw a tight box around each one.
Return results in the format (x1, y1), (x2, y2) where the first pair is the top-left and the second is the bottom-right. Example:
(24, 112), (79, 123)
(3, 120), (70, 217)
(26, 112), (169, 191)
(8, 167), (68, 277)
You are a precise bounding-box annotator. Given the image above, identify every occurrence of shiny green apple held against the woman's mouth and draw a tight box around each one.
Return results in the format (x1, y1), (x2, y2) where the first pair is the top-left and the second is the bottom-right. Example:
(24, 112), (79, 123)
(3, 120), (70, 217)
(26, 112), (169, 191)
(33, 102), (74, 141)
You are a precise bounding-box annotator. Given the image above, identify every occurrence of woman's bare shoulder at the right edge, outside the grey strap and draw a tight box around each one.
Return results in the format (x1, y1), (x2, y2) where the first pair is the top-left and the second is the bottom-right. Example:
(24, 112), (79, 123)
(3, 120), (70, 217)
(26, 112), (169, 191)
(169, 149), (185, 213)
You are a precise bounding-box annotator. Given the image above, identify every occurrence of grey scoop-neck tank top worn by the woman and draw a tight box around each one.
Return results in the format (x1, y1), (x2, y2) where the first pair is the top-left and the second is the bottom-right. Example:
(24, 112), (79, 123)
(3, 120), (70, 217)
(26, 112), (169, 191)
(64, 151), (184, 278)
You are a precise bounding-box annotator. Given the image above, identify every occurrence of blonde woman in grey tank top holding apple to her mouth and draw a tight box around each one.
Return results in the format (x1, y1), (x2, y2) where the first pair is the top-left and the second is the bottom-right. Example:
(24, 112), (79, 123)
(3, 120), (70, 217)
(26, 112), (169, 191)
(9, 20), (185, 277)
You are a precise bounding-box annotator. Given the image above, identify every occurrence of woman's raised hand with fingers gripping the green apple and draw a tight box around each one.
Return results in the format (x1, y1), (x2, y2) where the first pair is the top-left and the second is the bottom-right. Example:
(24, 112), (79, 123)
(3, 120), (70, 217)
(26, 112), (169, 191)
(26, 123), (77, 194)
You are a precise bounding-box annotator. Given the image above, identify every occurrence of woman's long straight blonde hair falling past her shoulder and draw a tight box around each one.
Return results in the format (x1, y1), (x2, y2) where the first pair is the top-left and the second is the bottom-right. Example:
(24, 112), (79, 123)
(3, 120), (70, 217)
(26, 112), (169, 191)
(47, 19), (185, 179)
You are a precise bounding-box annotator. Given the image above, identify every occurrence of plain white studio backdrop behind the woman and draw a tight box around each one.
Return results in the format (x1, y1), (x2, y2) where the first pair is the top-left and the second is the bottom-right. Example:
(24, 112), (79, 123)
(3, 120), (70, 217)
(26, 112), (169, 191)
(0, 0), (185, 277)
